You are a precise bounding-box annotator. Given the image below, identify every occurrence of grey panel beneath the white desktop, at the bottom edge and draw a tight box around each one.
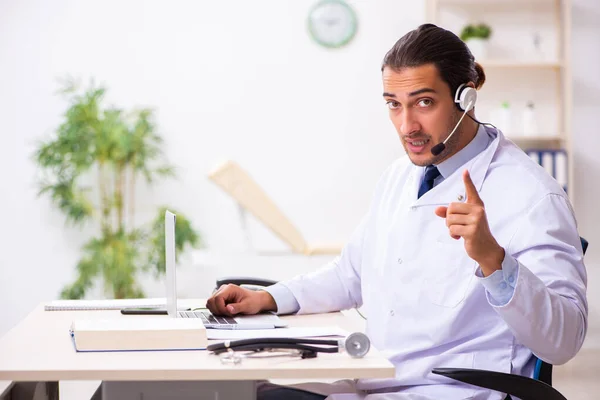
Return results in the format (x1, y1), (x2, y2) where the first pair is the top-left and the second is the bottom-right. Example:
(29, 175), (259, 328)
(99, 381), (256, 400)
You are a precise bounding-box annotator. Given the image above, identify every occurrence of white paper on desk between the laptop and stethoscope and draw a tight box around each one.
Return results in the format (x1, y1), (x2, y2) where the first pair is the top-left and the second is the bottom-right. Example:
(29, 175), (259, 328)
(206, 326), (349, 340)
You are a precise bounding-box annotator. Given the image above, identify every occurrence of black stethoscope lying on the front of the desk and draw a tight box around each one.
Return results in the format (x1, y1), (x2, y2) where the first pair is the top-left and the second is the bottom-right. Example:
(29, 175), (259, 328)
(207, 332), (371, 364)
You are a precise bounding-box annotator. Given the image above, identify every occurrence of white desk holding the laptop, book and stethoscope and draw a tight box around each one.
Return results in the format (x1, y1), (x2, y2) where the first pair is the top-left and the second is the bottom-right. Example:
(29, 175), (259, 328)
(0, 301), (394, 399)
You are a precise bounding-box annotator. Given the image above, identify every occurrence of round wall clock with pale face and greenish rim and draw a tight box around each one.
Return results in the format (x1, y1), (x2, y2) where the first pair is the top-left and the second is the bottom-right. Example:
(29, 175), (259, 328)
(308, 0), (357, 47)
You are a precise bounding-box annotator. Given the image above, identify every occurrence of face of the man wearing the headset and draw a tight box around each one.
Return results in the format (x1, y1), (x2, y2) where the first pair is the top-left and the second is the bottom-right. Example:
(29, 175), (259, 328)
(383, 64), (464, 166)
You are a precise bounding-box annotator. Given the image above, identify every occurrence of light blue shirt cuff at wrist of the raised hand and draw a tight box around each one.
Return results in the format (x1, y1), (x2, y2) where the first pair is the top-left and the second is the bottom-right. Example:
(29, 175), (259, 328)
(475, 253), (519, 307)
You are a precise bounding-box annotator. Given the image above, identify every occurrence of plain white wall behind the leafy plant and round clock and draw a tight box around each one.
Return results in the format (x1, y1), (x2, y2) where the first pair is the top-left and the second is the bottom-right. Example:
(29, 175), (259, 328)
(0, 0), (424, 334)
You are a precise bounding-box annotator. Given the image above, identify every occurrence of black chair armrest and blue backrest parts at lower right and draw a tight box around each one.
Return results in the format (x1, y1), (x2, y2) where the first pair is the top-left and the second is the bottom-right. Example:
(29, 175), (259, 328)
(431, 238), (589, 400)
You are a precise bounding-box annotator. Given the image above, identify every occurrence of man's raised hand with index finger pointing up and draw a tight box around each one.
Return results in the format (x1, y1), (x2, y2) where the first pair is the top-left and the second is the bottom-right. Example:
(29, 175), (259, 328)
(435, 170), (504, 276)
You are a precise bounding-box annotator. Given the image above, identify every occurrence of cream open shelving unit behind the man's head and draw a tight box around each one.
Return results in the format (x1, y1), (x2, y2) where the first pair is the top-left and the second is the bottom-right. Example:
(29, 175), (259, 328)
(425, 0), (574, 203)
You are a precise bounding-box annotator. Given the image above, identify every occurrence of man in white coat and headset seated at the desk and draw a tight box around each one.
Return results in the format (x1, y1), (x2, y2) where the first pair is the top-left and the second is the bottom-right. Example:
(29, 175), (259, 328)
(207, 24), (588, 400)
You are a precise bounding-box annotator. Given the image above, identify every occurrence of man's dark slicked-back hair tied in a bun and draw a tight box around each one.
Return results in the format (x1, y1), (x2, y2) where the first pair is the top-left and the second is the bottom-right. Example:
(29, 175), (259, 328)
(381, 24), (485, 96)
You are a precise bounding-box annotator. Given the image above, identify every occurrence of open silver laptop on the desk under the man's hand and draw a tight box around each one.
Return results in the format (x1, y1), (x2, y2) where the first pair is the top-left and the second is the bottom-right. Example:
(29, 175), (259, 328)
(165, 210), (287, 329)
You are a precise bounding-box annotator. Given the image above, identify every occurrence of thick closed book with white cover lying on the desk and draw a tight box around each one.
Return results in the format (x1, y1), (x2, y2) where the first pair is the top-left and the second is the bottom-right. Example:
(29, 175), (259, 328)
(69, 317), (208, 352)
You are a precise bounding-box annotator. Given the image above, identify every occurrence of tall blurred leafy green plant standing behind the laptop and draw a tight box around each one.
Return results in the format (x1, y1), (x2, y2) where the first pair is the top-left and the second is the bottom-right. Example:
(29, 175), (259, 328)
(34, 80), (201, 299)
